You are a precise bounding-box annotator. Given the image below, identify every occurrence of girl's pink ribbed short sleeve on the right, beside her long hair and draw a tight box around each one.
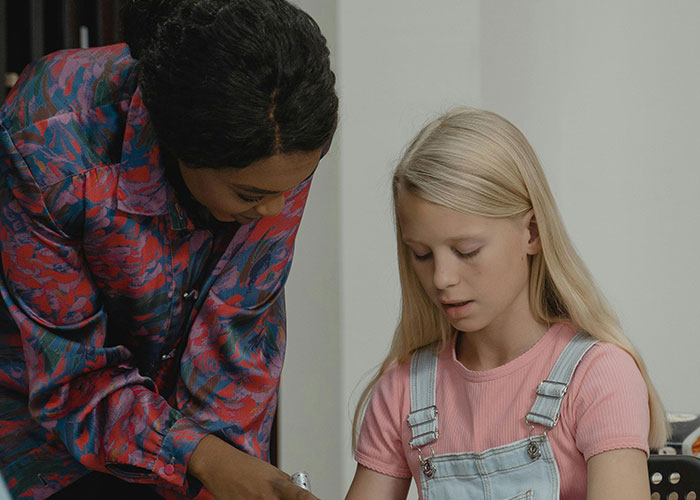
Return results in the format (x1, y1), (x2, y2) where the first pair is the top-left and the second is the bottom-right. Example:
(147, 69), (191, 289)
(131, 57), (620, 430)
(572, 343), (649, 461)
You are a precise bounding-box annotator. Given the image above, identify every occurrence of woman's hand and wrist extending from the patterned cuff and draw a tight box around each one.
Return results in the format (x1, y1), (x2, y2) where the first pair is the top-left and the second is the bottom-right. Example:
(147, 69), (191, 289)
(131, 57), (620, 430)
(187, 434), (318, 500)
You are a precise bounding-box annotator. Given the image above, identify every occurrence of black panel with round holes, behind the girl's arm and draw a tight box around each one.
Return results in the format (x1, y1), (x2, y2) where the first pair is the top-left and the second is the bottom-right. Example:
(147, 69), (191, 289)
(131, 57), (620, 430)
(647, 455), (700, 500)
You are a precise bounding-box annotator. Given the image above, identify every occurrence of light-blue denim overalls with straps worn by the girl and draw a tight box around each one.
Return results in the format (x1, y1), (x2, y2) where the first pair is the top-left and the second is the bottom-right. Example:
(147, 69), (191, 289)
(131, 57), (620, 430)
(407, 333), (596, 500)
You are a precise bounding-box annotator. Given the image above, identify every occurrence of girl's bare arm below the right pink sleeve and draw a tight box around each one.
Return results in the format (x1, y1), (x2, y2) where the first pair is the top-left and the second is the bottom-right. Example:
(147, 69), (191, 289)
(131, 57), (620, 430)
(587, 448), (651, 500)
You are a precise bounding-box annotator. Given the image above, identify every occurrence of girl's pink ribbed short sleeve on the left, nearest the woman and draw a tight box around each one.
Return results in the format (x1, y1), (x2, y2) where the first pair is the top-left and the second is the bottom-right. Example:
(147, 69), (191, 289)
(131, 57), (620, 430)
(355, 366), (411, 478)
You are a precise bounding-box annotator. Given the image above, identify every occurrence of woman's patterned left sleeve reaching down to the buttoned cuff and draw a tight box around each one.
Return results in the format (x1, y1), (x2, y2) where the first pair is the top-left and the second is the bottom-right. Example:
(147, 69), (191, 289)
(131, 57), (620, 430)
(0, 126), (207, 494)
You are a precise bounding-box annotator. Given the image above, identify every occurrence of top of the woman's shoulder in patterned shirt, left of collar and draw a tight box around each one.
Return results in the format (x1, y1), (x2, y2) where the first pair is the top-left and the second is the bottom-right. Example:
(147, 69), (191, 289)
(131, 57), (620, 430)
(0, 44), (136, 134)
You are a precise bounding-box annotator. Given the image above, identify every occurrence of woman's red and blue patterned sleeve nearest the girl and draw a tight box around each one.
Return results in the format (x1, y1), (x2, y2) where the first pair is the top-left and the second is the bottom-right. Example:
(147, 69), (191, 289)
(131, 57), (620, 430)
(172, 179), (311, 459)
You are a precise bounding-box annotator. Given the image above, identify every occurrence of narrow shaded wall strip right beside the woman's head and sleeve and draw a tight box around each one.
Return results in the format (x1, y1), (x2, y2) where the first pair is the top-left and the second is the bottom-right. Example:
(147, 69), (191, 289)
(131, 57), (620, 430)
(278, 0), (344, 498)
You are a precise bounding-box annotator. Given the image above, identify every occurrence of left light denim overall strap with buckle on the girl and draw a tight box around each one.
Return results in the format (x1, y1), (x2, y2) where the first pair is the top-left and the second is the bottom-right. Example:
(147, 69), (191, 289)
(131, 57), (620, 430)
(406, 346), (438, 449)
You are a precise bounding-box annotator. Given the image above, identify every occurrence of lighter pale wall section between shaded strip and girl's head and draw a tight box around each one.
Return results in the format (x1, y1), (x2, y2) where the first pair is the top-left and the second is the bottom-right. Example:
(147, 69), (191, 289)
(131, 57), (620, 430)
(338, 0), (480, 494)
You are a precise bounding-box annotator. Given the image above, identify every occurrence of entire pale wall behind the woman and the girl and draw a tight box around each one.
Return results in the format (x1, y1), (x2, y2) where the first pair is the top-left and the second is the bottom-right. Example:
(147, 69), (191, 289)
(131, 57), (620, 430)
(280, 0), (700, 499)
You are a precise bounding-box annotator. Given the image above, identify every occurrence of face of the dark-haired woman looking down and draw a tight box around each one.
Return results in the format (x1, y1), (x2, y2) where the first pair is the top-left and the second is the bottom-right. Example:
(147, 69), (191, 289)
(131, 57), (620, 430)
(179, 149), (321, 224)
